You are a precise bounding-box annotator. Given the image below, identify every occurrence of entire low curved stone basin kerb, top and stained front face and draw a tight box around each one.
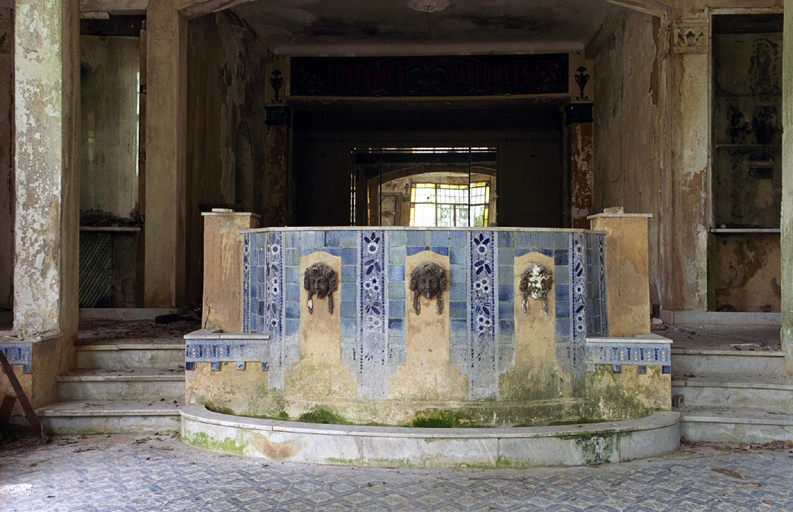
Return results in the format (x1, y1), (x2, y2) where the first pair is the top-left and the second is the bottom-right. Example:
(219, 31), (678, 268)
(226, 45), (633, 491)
(179, 405), (680, 468)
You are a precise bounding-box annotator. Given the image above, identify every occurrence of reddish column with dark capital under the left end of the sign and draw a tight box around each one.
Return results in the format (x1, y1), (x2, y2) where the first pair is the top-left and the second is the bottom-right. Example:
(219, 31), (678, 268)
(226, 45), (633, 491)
(262, 106), (292, 227)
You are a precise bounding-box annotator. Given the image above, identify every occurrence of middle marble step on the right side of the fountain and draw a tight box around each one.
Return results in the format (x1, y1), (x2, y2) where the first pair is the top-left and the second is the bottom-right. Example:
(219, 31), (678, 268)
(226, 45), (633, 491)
(672, 374), (793, 412)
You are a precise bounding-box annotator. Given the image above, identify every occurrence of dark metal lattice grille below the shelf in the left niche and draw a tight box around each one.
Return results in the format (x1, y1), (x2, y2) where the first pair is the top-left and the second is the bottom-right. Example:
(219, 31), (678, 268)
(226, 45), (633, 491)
(80, 232), (113, 308)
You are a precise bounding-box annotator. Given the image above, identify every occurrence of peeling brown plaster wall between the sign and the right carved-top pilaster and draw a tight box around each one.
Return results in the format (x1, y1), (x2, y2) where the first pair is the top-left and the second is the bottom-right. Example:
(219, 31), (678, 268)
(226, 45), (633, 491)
(588, 11), (669, 304)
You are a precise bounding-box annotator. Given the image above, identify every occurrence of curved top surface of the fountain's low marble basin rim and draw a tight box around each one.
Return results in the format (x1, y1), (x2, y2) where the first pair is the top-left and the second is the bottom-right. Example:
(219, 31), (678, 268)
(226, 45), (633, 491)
(179, 405), (680, 439)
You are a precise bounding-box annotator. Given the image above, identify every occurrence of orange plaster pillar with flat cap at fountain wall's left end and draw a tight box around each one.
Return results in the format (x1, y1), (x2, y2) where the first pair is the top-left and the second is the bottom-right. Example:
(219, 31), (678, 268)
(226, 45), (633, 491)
(201, 208), (260, 333)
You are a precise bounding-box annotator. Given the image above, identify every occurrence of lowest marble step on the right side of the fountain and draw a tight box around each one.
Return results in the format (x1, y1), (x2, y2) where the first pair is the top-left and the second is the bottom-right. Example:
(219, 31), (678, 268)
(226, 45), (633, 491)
(676, 407), (793, 443)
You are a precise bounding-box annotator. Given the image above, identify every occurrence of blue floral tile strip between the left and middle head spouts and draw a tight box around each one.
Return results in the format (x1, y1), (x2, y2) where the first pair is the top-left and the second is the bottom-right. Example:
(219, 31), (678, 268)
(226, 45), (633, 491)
(357, 231), (388, 400)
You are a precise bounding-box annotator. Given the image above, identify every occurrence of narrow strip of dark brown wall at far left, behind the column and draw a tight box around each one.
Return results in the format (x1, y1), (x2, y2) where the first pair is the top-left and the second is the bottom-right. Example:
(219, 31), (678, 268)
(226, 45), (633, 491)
(0, 0), (16, 309)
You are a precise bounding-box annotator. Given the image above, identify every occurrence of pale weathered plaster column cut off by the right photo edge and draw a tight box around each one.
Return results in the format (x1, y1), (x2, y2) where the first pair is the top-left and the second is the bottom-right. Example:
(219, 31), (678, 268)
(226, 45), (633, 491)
(780, 0), (793, 375)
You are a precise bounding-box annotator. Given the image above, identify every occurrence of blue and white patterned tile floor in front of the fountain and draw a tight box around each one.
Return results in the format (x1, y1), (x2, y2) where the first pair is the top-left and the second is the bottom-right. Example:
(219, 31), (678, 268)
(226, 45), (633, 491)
(0, 436), (793, 511)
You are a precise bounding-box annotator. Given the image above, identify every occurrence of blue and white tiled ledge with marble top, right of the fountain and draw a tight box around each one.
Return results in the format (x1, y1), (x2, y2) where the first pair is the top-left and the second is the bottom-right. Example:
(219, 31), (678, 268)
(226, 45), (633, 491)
(586, 334), (672, 374)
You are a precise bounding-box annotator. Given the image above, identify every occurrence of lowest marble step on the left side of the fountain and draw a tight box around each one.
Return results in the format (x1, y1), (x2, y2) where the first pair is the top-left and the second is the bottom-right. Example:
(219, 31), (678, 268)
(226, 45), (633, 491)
(30, 400), (183, 434)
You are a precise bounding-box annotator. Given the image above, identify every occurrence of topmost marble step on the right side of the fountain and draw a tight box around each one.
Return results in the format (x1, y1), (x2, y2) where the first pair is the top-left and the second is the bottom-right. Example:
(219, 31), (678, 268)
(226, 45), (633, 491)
(672, 348), (786, 377)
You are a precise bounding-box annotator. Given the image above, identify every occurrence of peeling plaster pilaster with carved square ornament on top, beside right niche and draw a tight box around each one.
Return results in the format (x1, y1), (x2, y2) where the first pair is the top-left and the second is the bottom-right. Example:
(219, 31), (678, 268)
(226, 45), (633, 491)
(663, 18), (711, 311)
